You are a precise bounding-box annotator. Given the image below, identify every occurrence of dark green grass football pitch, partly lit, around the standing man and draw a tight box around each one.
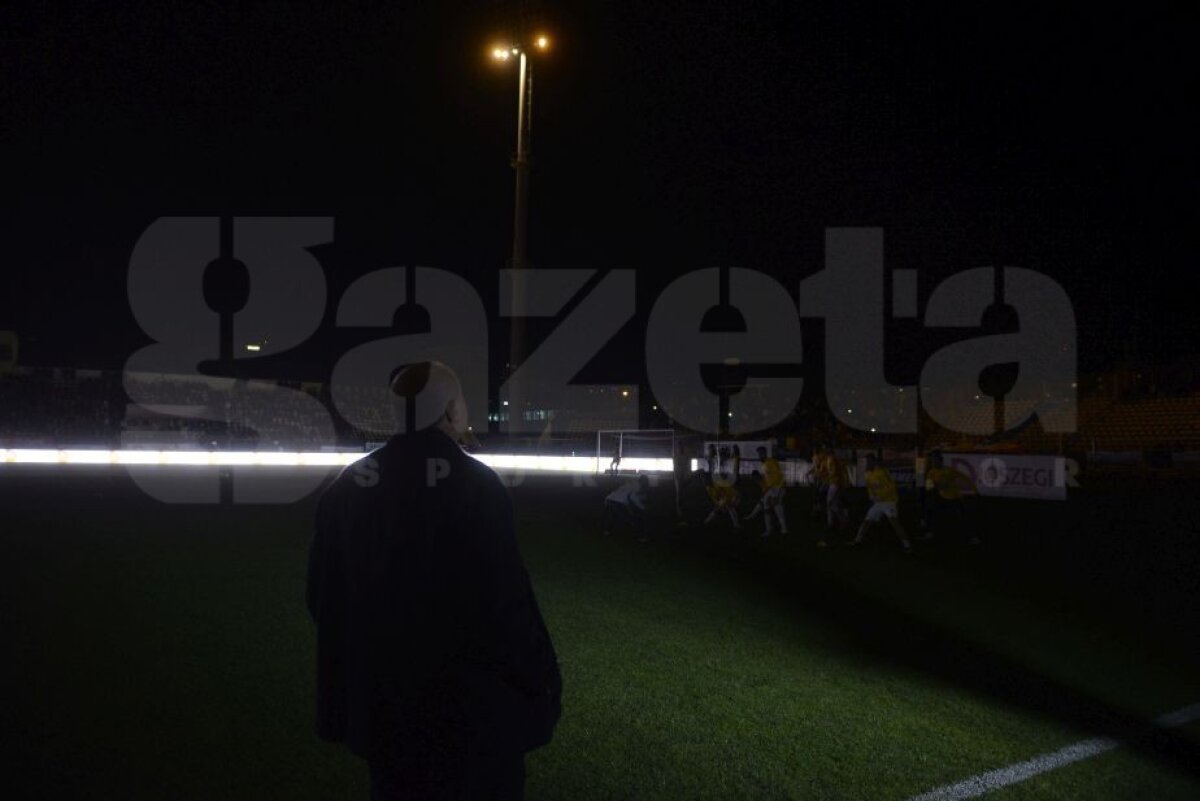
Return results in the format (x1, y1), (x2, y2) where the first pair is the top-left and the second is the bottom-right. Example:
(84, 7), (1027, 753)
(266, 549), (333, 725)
(0, 465), (1200, 799)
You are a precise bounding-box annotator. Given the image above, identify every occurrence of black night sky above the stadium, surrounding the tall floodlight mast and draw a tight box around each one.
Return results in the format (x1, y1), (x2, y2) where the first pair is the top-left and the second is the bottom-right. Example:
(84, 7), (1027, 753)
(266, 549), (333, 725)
(0, 0), (1198, 380)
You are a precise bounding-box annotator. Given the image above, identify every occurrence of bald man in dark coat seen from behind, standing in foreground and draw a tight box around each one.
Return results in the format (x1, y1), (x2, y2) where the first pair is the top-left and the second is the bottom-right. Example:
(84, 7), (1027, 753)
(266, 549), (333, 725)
(307, 362), (562, 801)
